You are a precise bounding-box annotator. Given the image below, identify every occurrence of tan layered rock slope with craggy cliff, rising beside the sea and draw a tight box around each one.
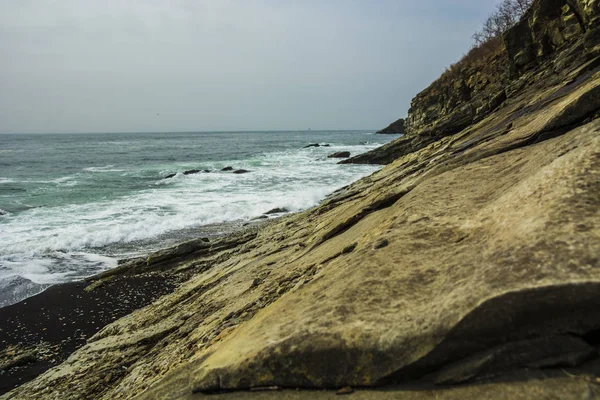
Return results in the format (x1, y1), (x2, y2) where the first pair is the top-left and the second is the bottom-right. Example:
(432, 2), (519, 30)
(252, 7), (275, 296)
(3, 0), (600, 399)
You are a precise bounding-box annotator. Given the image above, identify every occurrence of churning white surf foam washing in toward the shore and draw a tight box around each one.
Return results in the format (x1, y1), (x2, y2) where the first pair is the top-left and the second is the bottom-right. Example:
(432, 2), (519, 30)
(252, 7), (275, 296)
(0, 143), (379, 284)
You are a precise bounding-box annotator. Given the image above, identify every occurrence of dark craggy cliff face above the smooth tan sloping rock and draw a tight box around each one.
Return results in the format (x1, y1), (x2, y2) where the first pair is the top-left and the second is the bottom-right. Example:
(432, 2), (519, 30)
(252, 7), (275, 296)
(343, 0), (600, 164)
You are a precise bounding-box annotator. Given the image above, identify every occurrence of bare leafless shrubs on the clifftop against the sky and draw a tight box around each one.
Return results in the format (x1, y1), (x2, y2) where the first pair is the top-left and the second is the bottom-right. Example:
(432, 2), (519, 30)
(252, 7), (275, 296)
(472, 0), (533, 46)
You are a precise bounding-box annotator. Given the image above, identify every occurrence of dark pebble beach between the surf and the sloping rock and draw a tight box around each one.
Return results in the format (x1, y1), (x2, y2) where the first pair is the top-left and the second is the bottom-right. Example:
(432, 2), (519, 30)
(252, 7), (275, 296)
(0, 275), (176, 395)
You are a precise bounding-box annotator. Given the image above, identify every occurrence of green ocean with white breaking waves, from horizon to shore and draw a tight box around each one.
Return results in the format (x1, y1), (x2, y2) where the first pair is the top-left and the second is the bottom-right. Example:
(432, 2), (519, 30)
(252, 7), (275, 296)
(0, 131), (397, 307)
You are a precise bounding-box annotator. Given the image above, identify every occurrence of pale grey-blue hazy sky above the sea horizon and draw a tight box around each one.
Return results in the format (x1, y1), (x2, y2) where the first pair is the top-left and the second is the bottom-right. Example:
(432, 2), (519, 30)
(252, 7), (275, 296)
(0, 0), (497, 133)
